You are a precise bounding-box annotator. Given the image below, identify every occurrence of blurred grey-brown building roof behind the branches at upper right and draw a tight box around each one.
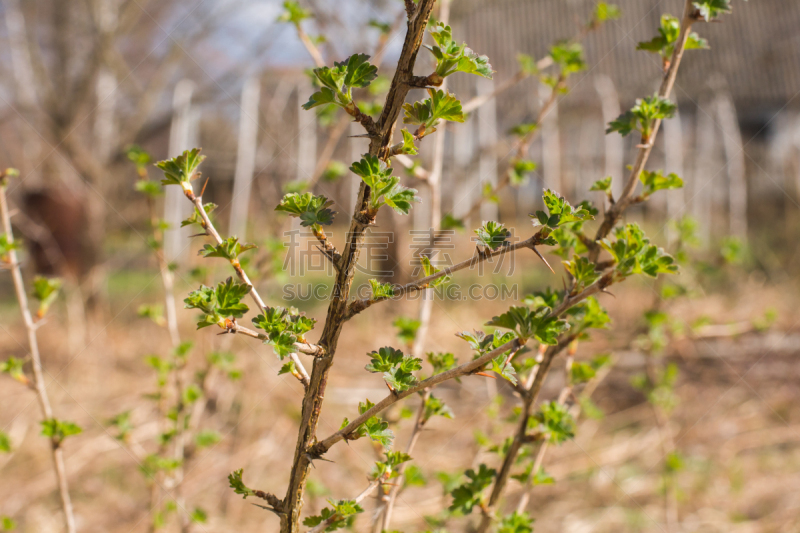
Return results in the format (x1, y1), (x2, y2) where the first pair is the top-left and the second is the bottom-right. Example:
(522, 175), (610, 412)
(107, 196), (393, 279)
(452, 0), (800, 113)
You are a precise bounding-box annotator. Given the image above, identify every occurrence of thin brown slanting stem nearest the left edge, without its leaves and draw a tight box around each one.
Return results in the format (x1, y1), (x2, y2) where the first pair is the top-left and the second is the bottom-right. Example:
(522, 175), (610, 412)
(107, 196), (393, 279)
(0, 176), (75, 533)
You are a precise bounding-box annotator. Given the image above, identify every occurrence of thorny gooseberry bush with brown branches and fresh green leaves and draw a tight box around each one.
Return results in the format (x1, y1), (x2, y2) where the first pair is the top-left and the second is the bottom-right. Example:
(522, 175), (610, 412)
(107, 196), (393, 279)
(28, 0), (730, 533)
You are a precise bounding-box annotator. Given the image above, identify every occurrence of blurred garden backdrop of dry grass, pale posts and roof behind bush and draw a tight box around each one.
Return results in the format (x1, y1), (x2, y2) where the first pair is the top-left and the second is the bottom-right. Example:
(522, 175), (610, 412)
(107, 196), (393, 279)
(0, 0), (800, 533)
